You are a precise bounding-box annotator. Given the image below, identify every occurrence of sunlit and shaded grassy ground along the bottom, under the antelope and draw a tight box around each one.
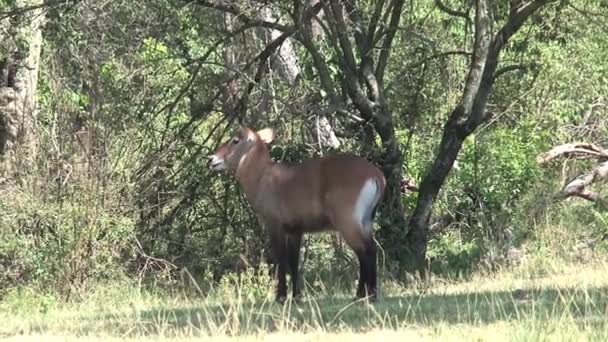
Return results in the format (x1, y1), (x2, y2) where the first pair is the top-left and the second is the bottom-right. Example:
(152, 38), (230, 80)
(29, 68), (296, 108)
(0, 264), (608, 341)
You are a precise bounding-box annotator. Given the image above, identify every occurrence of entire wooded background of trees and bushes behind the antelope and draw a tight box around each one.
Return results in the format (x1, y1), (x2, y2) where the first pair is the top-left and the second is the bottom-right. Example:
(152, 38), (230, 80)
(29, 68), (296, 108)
(0, 0), (608, 336)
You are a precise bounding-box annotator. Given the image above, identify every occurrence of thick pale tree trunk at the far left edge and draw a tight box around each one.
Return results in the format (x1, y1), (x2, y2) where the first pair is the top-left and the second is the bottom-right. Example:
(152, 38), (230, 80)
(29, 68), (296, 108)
(0, 0), (44, 185)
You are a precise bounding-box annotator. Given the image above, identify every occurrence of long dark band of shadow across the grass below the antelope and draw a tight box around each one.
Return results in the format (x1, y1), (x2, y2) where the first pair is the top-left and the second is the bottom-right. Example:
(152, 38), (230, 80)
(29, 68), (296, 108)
(48, 287), (608, 336)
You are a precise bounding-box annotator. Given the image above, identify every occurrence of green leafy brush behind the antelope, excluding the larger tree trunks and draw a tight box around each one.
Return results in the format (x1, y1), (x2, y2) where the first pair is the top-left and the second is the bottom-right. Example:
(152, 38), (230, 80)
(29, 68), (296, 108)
(0, 0), (608, 320)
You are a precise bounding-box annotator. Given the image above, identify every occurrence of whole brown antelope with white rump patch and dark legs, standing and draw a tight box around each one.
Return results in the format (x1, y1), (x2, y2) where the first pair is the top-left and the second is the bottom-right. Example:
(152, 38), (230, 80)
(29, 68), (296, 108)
(209, 127), (386, 301)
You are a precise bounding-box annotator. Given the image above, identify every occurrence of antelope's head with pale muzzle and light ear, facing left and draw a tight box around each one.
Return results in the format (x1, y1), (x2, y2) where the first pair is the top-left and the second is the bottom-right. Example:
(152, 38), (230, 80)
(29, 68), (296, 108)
(207, 126), (275, 171)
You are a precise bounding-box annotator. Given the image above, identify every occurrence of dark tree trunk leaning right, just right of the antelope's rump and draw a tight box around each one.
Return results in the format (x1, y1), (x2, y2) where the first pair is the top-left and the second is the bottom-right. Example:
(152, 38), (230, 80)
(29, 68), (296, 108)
(407, 0), (552, 273)
